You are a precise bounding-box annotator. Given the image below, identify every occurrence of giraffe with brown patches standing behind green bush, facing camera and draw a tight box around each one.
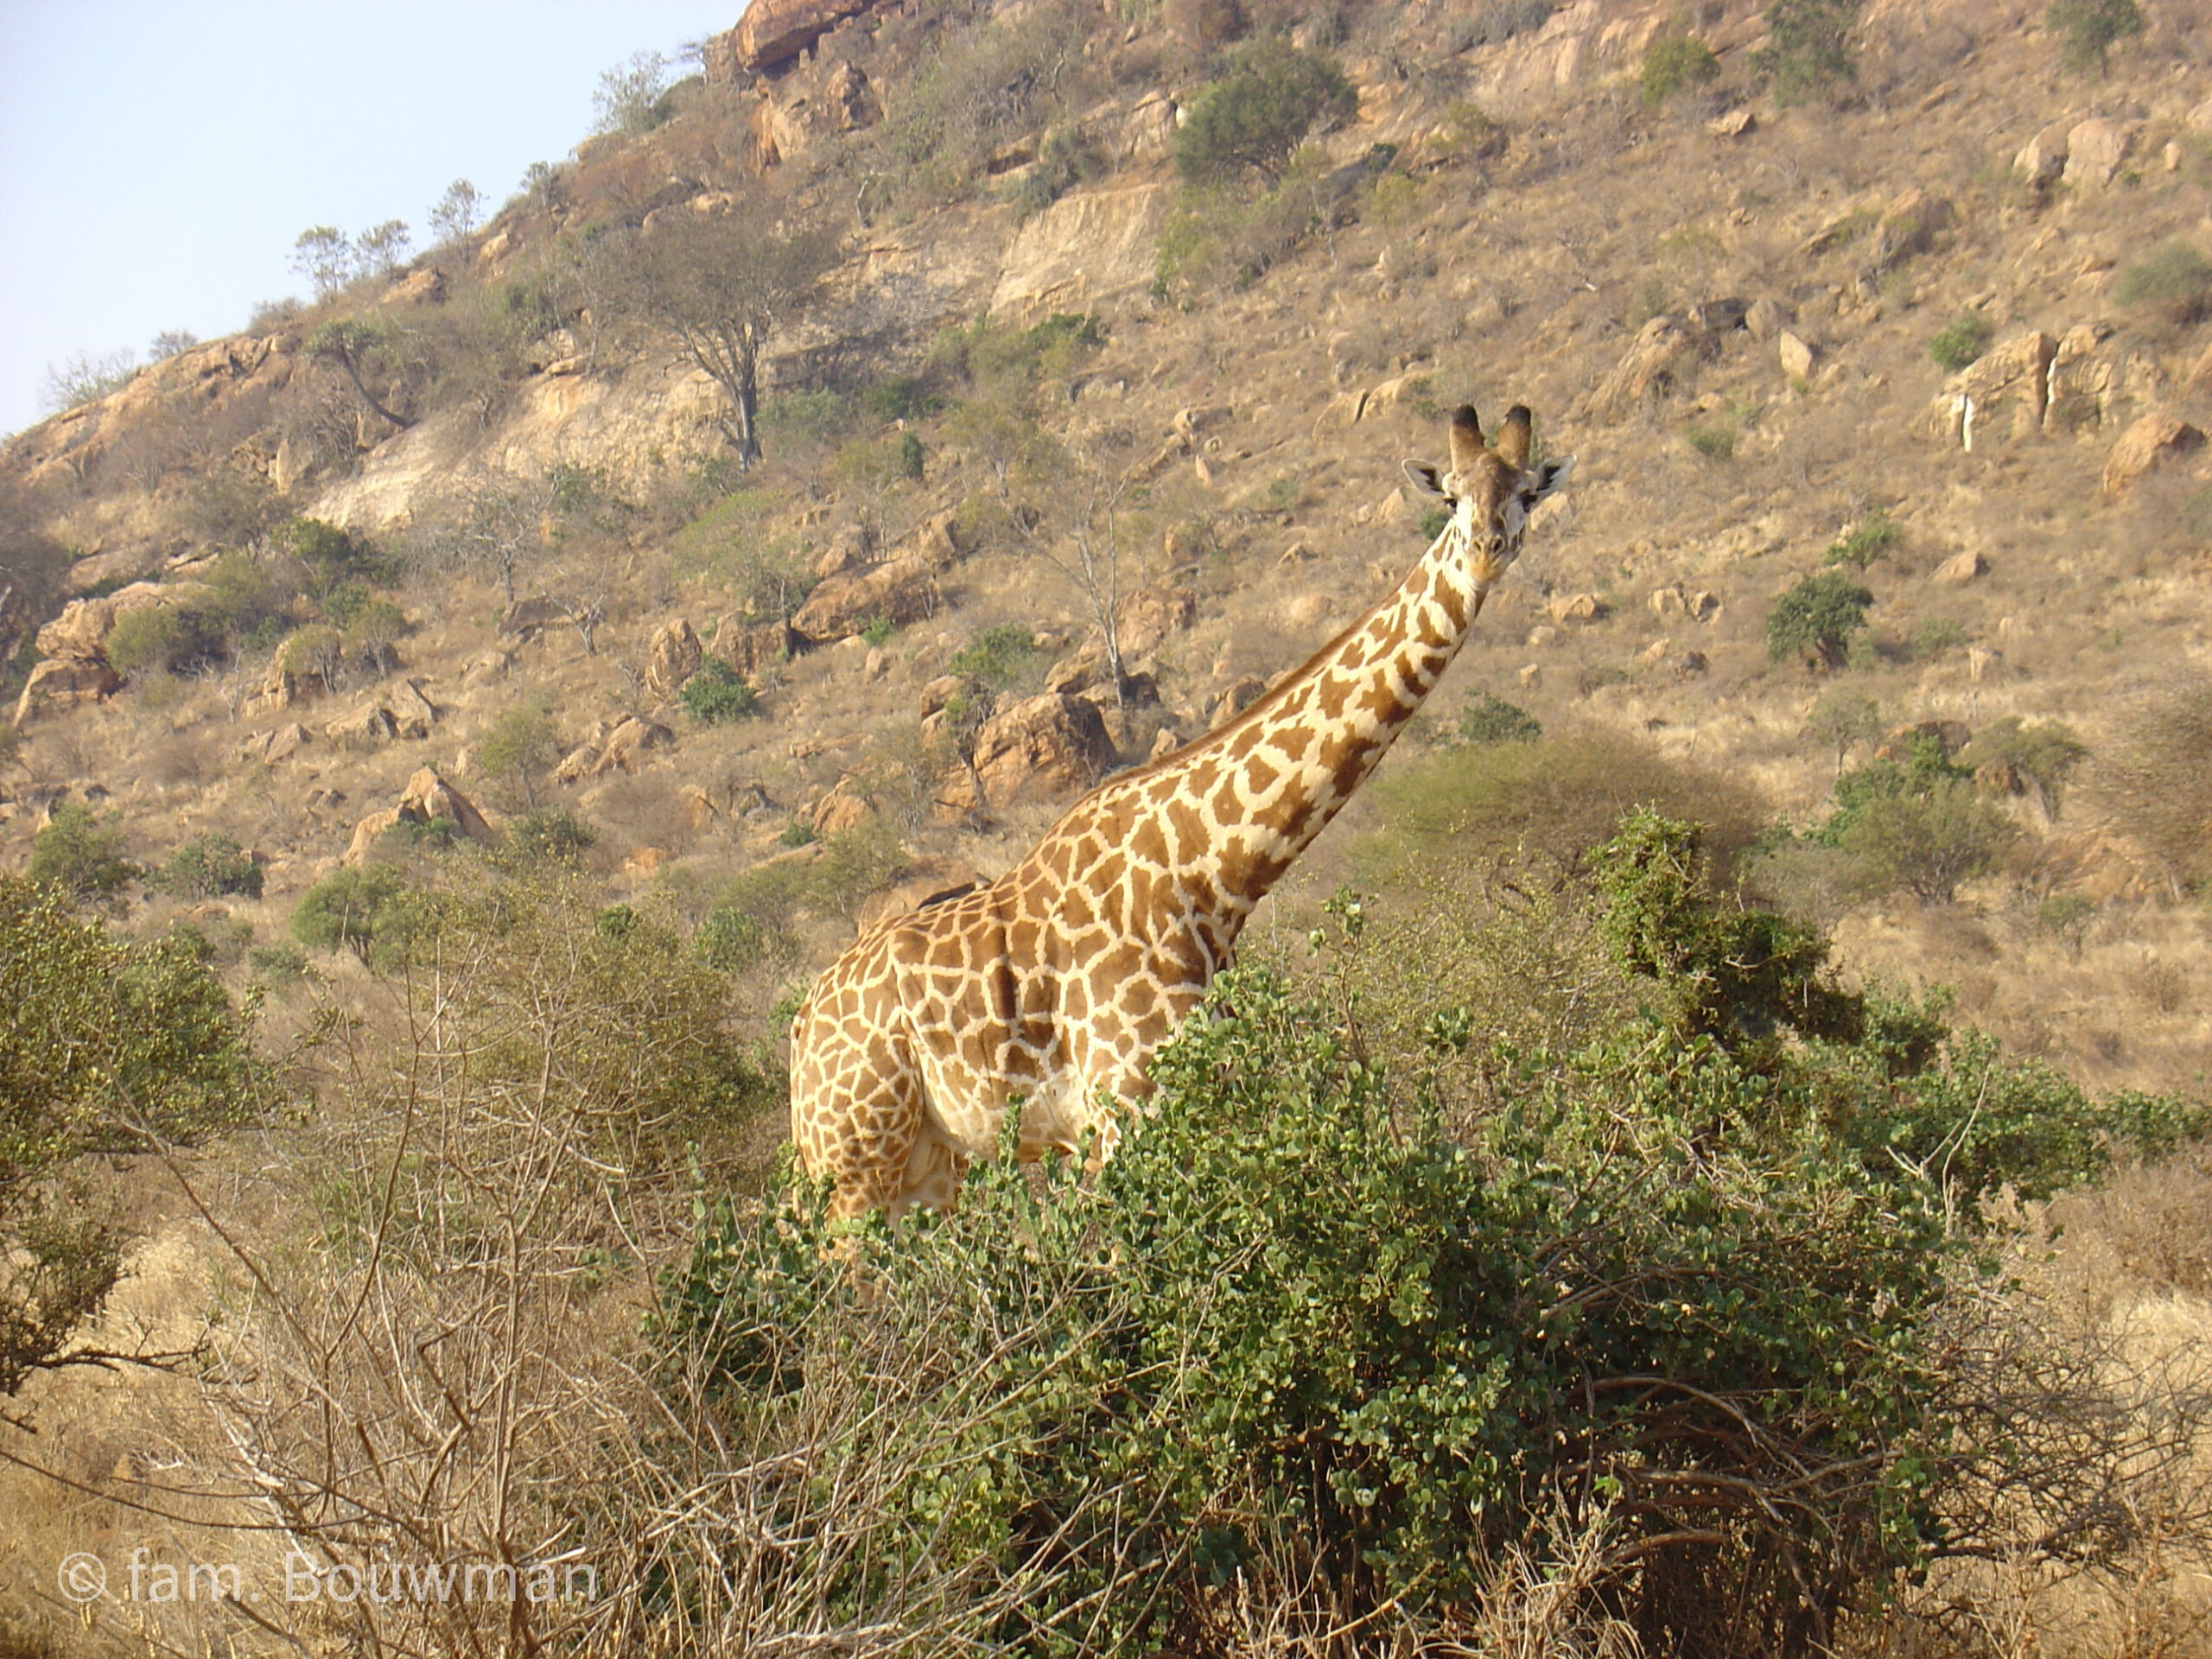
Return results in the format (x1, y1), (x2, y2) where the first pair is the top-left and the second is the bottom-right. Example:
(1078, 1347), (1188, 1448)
(791, 404), (1573, 1221)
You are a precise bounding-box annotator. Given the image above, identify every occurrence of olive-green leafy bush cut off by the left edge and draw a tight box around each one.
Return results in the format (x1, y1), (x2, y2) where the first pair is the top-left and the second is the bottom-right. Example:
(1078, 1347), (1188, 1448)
(0, 876), (274, 1395)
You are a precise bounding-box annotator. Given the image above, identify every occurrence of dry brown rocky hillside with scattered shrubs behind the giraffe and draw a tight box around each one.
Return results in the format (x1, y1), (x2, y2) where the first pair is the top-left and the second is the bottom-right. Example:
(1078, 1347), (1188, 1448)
(0, 0), (2212, 1652)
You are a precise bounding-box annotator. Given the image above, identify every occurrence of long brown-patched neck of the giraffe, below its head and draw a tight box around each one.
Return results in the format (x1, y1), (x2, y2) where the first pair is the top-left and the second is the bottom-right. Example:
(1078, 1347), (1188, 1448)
(1164, 526), (1486, 936)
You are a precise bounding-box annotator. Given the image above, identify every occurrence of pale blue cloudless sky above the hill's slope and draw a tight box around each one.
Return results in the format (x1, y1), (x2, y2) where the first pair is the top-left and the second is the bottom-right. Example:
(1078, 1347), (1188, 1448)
(0, 0), (743, 434)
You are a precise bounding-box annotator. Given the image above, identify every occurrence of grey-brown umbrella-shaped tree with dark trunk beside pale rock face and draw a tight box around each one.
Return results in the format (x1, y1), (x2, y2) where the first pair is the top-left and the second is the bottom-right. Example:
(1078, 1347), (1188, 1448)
(615, 201), (836, 467)
